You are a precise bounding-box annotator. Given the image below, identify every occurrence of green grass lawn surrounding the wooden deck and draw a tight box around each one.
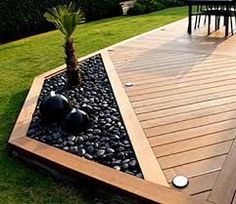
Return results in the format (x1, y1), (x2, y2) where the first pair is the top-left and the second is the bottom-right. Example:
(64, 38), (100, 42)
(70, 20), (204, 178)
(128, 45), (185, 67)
(0, 7), (187, 204)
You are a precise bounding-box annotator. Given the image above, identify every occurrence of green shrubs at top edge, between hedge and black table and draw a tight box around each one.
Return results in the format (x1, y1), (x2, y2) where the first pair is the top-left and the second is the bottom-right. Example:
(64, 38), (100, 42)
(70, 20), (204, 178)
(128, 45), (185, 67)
(128, 0), (166, 15)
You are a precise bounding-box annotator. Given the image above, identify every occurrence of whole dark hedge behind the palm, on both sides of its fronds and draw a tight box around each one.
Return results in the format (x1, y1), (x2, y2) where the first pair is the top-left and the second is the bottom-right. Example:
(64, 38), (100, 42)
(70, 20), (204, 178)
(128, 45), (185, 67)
(0, 0), (119, 42)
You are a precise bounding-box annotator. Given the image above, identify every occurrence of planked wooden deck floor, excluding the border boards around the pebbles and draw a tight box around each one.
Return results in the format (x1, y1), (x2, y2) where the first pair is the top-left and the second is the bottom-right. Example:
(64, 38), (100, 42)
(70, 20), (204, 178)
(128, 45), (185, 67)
(108, 20), (236, 204)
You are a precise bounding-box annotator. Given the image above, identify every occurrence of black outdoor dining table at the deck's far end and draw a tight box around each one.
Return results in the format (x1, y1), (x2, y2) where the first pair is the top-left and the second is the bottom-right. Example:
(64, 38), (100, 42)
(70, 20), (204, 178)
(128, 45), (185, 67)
(188, 0), (234, 36)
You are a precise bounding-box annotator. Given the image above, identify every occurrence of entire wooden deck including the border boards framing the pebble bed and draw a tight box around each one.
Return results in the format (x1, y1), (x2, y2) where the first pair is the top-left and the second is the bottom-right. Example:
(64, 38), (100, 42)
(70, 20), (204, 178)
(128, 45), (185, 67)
(9, 17), (236, 204)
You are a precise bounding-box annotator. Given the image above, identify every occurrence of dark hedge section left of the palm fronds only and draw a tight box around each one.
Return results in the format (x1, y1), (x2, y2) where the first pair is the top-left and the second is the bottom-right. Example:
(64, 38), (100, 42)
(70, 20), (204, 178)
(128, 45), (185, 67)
(0, 0), (67, 41)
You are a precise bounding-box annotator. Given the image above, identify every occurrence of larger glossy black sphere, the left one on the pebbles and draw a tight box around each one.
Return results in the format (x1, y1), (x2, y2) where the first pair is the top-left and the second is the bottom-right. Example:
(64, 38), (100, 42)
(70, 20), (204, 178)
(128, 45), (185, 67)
(39, 91), (71, 124)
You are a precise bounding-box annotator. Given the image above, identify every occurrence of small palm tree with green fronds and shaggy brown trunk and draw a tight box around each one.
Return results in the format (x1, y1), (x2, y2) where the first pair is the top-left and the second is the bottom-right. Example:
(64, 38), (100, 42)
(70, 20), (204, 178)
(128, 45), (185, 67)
(44, 3), (82, 86)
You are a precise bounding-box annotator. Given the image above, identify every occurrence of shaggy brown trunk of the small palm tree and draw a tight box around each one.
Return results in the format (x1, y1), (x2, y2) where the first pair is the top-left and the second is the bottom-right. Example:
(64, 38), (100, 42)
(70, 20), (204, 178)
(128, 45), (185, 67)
(65, 38), (81, 86)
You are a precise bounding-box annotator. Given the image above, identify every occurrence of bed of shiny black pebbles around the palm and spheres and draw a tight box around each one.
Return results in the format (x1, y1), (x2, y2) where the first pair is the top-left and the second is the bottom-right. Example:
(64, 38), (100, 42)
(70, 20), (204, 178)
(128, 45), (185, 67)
(27, 55), (143, 178)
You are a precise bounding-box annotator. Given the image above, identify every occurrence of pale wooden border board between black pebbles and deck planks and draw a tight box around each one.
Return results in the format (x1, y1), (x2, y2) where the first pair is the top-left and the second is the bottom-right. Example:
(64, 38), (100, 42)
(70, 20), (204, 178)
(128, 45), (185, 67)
(101, 50), (169, 187)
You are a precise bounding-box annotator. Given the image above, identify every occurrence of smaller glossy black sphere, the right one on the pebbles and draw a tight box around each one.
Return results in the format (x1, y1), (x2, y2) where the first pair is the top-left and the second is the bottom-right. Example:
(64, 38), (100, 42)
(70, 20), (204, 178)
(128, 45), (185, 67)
(63, 108), (90, 133)
